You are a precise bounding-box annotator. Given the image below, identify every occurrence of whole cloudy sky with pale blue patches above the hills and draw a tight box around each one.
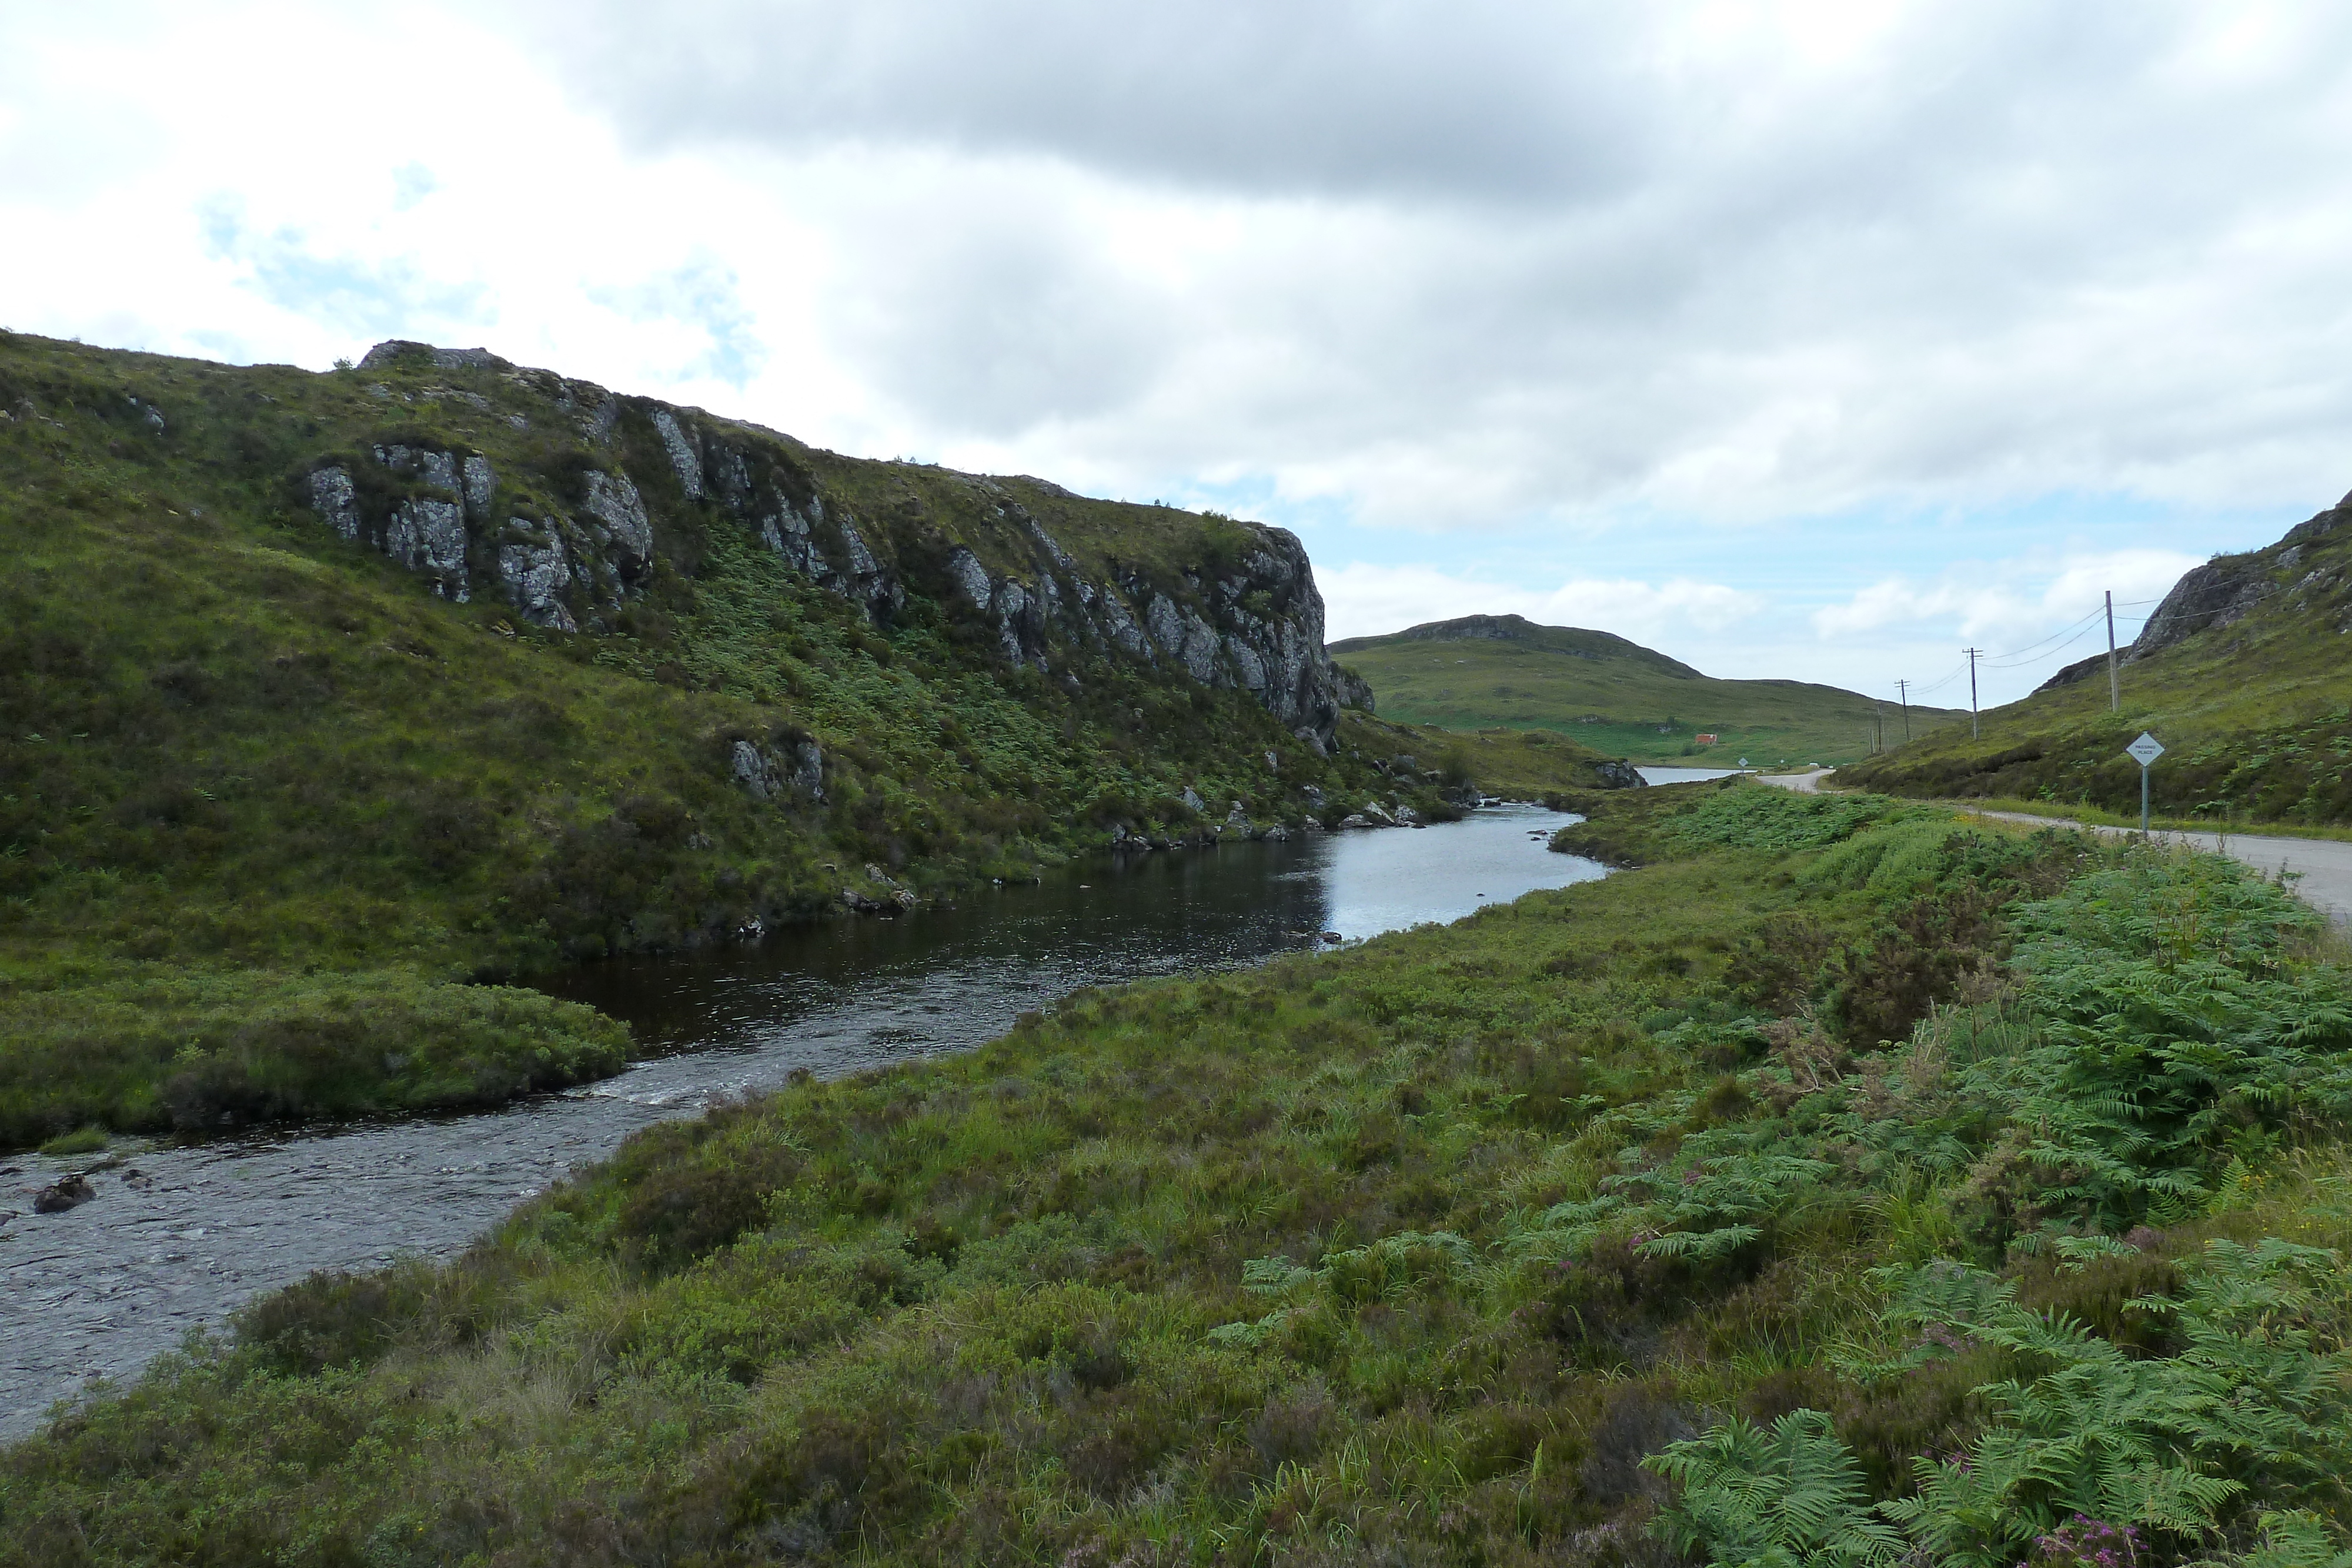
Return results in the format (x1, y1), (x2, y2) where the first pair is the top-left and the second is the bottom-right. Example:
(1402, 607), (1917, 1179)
(0, 0), (2352, 703)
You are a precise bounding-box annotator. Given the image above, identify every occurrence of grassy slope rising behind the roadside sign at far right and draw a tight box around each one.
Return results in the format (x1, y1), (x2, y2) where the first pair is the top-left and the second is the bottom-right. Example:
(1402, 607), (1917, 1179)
(1839, 493), (2352, 825)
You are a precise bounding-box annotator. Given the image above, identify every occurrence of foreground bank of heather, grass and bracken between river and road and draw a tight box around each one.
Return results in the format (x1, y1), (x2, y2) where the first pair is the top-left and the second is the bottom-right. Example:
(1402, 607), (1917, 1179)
(14, 785), (2352, 1568)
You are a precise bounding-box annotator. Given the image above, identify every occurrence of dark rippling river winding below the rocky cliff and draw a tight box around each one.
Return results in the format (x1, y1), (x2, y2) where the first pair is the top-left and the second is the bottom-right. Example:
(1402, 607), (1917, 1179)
(0, 806), (1602, 1436)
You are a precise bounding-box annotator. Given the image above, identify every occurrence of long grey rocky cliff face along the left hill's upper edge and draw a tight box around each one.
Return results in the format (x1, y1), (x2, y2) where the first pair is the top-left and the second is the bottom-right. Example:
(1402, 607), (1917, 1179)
(301, 343), (1371, 750)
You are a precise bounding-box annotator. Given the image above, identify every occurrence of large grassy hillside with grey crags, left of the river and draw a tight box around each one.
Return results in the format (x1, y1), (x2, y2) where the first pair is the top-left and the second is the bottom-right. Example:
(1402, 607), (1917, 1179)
(0, 334), (1595, 1147)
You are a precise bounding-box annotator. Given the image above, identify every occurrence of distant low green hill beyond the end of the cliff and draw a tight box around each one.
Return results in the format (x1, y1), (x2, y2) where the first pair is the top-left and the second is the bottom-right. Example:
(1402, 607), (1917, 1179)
(1331, 616), (1966, 764)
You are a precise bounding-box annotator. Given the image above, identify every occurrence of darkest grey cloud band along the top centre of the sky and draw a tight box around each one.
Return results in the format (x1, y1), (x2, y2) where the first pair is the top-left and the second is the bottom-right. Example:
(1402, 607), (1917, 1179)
(482, 0), (1656, 198)
